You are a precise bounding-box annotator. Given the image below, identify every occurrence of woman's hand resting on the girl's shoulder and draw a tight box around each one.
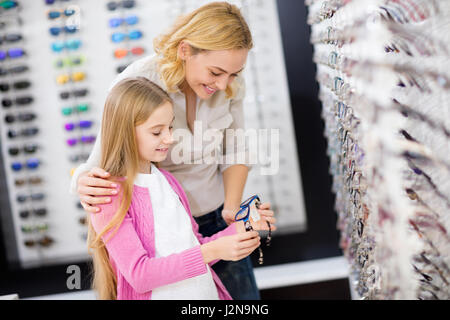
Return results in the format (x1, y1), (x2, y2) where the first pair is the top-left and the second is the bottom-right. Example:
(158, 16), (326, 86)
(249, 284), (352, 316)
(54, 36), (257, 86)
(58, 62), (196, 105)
(77, 168), (118, 213)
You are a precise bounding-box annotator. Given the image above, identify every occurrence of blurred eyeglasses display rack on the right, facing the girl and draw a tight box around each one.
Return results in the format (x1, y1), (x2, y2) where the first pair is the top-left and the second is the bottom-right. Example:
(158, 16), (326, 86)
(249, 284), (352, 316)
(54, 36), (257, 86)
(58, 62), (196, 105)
(305, 0), (450, 299)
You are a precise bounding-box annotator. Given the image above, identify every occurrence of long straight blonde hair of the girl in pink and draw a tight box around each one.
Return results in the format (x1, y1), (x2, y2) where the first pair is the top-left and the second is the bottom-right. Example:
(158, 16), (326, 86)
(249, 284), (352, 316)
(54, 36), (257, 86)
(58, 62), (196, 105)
(87, 77), (172, 299)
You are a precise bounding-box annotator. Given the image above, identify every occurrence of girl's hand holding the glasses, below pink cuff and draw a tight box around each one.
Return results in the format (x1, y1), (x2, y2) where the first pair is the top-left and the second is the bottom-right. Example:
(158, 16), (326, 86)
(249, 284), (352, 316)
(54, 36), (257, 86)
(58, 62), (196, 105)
(200, 231), (261, 263)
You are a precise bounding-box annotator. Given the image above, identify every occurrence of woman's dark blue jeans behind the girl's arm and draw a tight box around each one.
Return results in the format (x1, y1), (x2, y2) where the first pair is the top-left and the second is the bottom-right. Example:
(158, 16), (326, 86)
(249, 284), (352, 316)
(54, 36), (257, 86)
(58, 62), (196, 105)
(195, 205), (261, 300)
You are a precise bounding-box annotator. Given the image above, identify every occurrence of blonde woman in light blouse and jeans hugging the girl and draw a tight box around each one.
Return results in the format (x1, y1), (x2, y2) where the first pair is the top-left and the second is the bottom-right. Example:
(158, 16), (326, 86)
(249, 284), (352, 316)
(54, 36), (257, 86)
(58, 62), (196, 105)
(72, 2), (275, 300)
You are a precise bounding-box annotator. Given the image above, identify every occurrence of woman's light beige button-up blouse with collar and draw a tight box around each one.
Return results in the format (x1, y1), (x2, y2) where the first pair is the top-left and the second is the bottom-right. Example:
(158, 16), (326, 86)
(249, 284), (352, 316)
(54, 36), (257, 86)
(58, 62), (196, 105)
(71, 55), (250, 217)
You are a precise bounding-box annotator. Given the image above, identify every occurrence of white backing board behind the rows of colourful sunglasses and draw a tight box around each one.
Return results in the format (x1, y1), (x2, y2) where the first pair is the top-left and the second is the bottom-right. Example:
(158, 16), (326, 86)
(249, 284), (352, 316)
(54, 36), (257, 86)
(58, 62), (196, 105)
(0, 0), (306, 267)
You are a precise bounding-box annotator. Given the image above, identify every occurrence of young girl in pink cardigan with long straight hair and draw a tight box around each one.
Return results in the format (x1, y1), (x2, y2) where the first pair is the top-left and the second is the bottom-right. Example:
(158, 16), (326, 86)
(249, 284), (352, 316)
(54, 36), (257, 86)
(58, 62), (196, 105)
(88, 77), (268, 299)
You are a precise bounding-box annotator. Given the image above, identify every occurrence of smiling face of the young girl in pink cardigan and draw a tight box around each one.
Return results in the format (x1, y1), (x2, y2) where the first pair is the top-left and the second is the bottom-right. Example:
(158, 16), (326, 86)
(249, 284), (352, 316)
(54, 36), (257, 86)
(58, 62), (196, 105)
(136, 102), (174, 173)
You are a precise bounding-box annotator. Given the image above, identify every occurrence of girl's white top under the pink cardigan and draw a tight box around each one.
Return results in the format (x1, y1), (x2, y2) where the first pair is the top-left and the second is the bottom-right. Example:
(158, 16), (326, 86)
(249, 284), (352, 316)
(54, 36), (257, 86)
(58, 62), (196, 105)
(134, 164), (219, 300)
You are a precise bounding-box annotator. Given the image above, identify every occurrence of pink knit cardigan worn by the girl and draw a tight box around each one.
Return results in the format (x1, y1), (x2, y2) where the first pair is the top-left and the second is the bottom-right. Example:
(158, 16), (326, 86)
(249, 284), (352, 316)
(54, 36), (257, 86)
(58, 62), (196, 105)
(90, 169), (236, 300)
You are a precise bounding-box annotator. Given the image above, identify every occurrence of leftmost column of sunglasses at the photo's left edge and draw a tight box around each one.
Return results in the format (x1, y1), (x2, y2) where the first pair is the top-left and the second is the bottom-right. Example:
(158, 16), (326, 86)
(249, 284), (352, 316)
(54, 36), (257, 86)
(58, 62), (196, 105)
(0, 1), (46, 268)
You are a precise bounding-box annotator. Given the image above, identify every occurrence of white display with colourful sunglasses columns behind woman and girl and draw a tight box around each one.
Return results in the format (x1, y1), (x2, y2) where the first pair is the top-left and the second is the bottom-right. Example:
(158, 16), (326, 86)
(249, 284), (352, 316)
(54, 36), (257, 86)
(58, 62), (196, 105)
(0, 0), (306, 268)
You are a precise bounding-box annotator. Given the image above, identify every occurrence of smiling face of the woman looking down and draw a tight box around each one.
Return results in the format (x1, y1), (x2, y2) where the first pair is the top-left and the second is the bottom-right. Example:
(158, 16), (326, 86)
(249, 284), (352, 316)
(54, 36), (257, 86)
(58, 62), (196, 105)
(180, 43), (248, 99)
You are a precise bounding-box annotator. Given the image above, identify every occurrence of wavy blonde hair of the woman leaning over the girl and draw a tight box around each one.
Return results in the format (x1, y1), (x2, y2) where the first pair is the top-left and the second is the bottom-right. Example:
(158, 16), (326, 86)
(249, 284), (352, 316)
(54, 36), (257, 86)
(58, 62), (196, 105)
(153, 2), (253, 98)
